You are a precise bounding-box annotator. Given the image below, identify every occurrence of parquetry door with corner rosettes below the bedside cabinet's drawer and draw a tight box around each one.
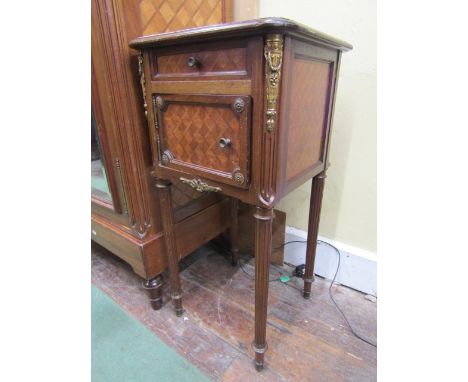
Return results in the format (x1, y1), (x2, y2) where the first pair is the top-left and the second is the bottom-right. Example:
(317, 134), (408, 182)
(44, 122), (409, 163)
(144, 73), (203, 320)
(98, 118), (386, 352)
(153, 94), (251, 188)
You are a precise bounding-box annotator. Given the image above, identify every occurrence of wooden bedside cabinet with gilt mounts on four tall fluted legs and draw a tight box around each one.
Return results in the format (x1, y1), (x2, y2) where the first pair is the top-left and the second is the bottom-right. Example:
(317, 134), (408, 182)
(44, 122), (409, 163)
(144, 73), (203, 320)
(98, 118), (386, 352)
(130, 18), (352, 370)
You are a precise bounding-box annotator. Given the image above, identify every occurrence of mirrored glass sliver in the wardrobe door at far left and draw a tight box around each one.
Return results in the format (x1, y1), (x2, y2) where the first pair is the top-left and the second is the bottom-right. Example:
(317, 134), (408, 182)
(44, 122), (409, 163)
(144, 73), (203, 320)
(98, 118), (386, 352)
(91, 111), (112, 203)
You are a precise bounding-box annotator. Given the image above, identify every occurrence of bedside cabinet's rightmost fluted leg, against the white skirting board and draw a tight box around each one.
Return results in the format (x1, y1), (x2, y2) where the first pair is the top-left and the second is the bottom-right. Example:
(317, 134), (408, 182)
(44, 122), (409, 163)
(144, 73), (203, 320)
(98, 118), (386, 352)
(303, 171), (326, 298)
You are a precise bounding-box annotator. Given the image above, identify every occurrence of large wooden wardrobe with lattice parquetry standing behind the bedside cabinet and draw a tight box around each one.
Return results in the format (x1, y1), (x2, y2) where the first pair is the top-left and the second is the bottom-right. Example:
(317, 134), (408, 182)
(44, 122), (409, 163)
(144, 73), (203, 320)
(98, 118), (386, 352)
(91, 0), (236, 308)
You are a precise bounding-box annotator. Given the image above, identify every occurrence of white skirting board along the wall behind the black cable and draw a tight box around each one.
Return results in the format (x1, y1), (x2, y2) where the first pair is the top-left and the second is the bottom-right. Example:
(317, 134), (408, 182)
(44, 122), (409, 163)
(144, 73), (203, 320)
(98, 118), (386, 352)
(284, 226), (377, 296)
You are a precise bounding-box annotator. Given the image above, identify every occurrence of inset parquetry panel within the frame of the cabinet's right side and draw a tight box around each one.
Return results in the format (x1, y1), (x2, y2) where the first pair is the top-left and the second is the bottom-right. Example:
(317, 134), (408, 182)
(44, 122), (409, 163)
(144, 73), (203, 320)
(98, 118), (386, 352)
(286, 53), (333, 183)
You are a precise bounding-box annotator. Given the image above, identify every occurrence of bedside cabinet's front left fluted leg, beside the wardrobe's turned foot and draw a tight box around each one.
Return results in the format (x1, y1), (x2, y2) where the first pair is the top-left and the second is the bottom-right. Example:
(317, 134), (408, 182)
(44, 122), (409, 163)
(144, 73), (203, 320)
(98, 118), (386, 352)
(156, 179), (184, 316)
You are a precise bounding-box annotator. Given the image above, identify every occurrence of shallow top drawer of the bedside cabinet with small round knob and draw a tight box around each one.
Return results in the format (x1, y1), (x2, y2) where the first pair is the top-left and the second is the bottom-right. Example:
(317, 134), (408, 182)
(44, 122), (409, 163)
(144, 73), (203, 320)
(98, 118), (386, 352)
(150, 41), (248, 80)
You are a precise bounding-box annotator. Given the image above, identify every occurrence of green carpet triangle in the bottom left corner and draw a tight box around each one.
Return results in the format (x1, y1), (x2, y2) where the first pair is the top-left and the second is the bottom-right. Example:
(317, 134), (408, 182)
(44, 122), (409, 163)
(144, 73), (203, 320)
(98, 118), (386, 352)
(91, 285), (209, 382)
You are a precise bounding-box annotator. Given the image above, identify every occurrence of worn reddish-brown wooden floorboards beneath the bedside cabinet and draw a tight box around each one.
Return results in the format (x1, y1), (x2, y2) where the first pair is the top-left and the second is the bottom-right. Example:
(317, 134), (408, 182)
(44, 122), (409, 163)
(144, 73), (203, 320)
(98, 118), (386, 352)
(92, 245), (377, 381)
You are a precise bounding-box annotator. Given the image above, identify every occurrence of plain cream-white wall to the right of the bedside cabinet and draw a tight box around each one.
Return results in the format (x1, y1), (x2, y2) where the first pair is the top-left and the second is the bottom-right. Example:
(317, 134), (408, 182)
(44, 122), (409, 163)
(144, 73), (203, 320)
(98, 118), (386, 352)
(259, 0), (377, 253)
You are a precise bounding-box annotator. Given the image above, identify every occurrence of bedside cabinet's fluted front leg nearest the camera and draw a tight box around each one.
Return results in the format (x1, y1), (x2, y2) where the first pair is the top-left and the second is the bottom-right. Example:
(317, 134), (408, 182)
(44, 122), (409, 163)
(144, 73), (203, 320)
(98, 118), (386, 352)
(253, 207), (274, 371)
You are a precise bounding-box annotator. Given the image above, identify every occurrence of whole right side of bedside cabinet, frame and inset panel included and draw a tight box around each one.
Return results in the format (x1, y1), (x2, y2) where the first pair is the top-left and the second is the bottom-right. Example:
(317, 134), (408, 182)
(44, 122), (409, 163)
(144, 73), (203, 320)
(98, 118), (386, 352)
(278, 36), (341, 196)
